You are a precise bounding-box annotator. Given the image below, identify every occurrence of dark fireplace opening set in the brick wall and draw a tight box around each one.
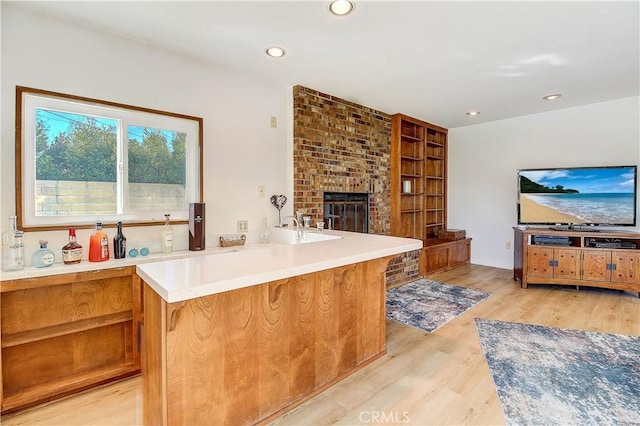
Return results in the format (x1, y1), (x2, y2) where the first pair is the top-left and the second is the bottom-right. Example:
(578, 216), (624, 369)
(322, 192), (369, 234)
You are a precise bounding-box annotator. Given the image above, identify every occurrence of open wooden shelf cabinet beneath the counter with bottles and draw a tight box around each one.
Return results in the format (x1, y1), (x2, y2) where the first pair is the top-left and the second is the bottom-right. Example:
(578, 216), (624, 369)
(0, 267), (142, 413)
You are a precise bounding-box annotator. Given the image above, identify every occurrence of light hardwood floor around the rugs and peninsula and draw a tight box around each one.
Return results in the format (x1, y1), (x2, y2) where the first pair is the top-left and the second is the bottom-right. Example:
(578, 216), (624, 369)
(1, 265), (640, 425)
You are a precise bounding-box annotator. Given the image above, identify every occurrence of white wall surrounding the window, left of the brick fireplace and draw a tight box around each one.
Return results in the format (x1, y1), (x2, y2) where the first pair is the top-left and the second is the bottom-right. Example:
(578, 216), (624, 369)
(0, 2), (293, 258)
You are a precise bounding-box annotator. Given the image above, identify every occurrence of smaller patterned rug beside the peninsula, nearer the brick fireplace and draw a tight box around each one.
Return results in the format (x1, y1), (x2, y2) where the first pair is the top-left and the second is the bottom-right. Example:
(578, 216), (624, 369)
(387, 278), (491, 333)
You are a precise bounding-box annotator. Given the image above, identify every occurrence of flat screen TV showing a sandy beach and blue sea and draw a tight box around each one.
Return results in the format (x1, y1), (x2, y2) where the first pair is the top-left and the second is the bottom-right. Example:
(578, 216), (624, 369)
(518, 166), (638, 228)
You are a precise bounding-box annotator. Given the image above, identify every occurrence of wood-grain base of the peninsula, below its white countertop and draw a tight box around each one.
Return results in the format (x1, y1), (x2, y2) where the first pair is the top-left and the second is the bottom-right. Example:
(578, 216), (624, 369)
(142, 258), (390, 425)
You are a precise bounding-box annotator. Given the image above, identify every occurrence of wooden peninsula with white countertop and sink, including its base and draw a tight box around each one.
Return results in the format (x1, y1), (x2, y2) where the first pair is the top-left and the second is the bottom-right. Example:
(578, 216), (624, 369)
(137, 229), (422, 425)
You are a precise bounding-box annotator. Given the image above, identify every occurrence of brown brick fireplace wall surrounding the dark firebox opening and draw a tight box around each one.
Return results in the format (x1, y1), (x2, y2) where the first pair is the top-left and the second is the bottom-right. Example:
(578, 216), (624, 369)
(293, 86), (419, 285)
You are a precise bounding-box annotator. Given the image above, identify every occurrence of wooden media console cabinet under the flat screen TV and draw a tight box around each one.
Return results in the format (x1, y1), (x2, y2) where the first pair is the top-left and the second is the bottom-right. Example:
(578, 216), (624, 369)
(513, 228), (640, 297)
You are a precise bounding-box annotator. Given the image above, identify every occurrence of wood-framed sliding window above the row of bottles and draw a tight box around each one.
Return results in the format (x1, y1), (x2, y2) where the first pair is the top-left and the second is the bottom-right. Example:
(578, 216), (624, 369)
(16, 87), (202, 230)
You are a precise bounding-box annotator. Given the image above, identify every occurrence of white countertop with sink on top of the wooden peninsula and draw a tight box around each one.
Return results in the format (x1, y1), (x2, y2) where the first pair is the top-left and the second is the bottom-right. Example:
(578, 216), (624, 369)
(137, 229), (422, 303)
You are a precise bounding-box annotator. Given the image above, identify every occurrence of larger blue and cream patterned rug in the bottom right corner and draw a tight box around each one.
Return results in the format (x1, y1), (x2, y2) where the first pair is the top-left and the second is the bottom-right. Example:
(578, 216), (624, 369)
(475, 318), (640, 425)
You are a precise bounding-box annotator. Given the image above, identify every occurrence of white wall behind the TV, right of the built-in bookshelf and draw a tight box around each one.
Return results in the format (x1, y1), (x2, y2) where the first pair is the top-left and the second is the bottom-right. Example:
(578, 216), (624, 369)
(448, 97), (640, 268)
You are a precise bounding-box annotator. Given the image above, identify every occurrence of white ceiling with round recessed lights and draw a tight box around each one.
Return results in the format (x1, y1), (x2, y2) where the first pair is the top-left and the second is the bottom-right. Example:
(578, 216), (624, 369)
(11, 0), (640, 128)
